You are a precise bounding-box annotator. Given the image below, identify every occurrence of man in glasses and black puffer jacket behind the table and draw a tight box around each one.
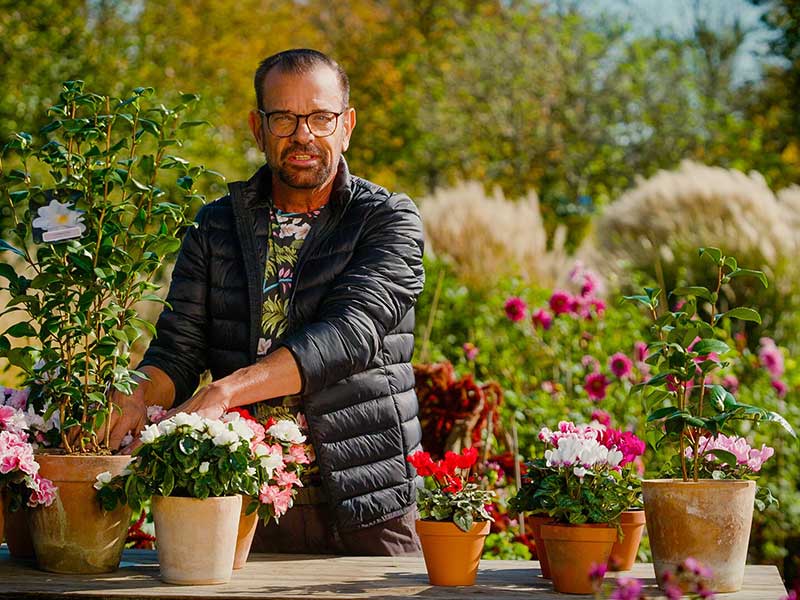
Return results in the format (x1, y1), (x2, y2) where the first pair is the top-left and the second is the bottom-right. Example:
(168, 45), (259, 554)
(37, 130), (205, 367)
(111, 50), (432, 555)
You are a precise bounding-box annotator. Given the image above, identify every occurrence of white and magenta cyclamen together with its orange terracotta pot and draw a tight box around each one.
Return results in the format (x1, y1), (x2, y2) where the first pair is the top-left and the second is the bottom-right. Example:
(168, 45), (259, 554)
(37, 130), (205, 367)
(512, 421), (644, 594)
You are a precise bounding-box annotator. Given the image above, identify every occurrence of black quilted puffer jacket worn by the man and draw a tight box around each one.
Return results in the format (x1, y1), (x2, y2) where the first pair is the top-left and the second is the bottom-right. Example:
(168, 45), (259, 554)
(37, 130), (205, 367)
(142, 159), (424, 531)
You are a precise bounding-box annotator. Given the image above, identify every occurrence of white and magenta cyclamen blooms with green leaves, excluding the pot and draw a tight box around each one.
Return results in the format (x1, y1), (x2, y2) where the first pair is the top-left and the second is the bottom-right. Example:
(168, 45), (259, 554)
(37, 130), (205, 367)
(511, 421), (645, 525)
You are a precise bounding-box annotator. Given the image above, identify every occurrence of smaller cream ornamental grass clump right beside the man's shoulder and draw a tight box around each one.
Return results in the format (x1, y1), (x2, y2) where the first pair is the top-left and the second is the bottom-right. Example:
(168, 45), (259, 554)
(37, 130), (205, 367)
(419, 182), (567, 288)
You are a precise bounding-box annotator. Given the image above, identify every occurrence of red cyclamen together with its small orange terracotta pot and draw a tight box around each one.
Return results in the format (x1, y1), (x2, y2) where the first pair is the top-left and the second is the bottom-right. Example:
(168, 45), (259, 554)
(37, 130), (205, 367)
(407, 447), (494, 586)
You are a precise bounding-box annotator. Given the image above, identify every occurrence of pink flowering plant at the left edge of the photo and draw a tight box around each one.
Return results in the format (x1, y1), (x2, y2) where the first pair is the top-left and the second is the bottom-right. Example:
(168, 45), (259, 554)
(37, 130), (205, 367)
(0, 388), (56, 511)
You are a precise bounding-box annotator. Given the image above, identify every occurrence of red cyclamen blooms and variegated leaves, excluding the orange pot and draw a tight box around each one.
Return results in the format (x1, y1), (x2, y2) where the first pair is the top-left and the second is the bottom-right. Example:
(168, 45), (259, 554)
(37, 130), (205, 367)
(407, 447), (495, 531)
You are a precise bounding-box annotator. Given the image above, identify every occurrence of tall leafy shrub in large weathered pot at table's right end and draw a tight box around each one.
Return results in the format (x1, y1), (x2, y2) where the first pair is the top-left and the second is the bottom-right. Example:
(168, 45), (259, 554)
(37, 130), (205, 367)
(626, 248), (795, 592)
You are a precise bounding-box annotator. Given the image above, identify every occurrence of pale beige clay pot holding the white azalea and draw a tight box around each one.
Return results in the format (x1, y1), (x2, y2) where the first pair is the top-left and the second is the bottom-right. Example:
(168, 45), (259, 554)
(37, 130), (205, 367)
(151, 496), (242, 585)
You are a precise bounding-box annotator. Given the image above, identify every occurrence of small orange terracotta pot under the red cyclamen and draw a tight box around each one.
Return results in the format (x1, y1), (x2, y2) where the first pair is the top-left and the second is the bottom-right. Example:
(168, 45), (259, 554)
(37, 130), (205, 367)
(416, 520), (490, 586)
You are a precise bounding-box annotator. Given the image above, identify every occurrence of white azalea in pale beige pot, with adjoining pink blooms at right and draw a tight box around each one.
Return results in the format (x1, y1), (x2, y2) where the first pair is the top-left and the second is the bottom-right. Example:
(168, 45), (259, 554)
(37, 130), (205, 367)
(96, 412), (307, 585)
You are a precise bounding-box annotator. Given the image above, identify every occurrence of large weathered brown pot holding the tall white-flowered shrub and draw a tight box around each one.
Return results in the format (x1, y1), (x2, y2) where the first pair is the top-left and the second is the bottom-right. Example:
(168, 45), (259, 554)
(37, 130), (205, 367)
(29, 454), (131, 573)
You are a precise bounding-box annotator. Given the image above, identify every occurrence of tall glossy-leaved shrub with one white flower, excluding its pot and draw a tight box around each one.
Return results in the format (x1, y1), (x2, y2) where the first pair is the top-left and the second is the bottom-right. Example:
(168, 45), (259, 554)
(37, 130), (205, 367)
(0, 81), (220, 453)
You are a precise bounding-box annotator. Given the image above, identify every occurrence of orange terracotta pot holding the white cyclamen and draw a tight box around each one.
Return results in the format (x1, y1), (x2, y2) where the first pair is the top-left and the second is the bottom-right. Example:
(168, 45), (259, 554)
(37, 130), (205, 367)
(542, 523), (617, 594)
